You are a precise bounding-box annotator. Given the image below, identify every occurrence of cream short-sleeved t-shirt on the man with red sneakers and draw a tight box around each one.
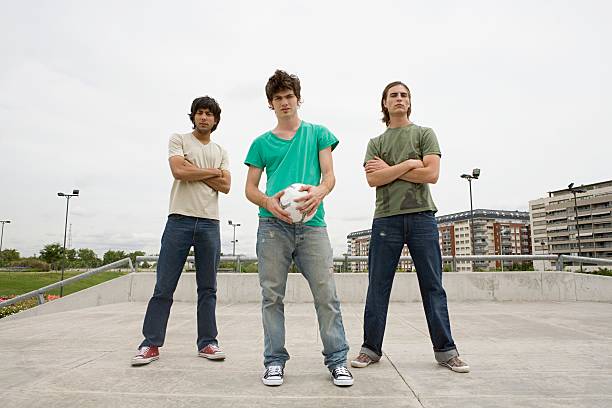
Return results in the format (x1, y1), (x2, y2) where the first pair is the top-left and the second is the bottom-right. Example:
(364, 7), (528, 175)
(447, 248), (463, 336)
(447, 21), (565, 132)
(168, 133), (229, 220)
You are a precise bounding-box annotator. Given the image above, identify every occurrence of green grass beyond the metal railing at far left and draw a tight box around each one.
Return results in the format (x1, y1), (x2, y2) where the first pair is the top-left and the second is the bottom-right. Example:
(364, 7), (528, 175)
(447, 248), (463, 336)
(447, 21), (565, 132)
(0, 271), (127, 297)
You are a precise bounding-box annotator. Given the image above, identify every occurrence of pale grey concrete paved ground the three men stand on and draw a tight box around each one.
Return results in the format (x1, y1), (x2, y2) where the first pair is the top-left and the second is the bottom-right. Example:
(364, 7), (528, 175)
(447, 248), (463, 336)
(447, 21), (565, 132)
(0, 302), (612, 408)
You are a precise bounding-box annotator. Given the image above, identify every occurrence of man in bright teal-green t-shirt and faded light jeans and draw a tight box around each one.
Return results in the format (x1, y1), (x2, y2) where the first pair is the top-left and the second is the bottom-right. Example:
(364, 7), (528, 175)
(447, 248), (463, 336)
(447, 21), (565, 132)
(244, 70), (353, 386)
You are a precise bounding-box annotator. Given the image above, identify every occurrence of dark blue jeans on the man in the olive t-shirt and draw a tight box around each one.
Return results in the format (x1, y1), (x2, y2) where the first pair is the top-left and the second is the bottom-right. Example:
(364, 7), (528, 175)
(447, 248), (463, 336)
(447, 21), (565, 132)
(361, 211), (459, 362)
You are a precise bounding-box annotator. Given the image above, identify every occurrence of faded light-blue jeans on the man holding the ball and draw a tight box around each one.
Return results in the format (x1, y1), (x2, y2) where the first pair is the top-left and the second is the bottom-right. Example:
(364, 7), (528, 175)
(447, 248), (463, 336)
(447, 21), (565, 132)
(257, 217), (349, 370)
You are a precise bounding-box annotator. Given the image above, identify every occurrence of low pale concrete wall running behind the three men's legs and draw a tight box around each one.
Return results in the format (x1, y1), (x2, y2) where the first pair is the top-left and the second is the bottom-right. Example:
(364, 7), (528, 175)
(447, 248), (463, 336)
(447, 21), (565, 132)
(5, 271), (612, 320)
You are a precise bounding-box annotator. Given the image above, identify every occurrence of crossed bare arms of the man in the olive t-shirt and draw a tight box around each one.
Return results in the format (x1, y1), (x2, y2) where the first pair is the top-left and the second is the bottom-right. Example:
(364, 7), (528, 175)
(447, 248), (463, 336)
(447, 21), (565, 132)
(365, 154), (440, 187)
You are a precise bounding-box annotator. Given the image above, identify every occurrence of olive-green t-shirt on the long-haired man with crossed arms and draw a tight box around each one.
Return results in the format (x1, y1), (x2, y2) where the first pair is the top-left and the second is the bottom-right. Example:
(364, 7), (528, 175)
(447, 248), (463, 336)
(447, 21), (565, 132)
(364, 123), (442, 218)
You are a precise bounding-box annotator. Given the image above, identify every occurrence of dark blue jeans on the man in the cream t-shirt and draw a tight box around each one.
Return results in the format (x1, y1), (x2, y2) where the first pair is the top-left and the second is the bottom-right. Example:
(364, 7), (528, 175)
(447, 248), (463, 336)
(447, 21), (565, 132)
(140, 214), (221, 350)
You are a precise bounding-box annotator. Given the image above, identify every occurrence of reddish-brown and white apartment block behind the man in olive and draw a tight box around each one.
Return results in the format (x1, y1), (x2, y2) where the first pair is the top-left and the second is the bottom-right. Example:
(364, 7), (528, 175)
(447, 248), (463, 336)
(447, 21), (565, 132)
(347, 209), (531, 272)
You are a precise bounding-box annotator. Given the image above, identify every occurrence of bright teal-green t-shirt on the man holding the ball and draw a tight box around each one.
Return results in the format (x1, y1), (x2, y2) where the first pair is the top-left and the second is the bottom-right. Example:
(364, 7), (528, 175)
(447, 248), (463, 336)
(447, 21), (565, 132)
(244, 121), (338, 227)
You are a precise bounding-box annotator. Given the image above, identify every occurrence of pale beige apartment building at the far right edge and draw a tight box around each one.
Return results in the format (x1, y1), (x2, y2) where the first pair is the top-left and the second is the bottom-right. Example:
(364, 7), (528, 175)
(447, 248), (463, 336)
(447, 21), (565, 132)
(529, 180), (612, 269)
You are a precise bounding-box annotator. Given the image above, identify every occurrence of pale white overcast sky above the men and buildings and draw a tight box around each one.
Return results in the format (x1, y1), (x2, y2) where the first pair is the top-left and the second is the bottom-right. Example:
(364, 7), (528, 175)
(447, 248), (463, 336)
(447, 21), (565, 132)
(0, 0), (612, 256)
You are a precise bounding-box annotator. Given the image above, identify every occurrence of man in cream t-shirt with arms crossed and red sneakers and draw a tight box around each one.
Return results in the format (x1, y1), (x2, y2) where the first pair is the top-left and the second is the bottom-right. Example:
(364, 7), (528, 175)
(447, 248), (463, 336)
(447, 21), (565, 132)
(132, 96), (231, 365)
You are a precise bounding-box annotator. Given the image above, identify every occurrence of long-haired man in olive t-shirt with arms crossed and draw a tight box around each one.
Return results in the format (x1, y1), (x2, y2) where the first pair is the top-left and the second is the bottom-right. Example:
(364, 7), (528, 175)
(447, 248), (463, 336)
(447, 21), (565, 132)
(351, 81), (470, 373)
